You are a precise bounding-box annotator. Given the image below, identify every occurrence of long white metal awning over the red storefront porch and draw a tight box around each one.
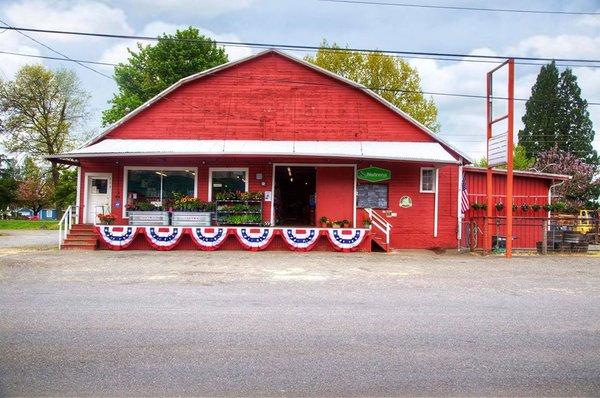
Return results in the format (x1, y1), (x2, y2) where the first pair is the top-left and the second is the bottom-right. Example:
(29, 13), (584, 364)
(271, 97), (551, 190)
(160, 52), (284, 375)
(49, 139), (458, 163)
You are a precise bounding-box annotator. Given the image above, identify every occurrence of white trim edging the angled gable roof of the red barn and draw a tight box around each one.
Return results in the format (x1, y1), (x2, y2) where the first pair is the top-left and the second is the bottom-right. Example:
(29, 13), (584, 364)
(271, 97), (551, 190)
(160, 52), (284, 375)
(82, 49), (472, 163)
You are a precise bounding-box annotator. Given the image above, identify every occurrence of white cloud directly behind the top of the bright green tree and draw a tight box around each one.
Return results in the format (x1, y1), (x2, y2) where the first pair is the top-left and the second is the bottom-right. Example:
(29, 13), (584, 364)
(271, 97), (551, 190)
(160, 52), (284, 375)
(100, 21), (252, 63)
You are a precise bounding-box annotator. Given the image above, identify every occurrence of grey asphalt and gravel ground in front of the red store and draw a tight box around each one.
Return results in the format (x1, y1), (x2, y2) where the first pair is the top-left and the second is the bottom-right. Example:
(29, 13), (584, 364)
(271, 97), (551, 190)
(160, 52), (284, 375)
(0, 248), (600, 396)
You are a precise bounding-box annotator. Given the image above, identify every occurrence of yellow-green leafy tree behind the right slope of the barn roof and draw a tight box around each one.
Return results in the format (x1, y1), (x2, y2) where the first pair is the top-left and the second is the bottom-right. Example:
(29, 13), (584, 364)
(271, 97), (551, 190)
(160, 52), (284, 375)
(304, 40), (440, 132)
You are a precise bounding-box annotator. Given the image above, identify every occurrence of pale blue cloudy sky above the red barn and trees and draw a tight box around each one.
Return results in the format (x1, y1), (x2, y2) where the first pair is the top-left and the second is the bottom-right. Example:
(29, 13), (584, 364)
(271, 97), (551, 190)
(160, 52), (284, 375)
(0, 0), (600, 157)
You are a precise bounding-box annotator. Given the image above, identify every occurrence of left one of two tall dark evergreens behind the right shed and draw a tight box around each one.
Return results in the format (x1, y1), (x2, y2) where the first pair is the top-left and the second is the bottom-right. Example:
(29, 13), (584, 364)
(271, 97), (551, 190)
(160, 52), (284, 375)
(519, 61), (560, 157)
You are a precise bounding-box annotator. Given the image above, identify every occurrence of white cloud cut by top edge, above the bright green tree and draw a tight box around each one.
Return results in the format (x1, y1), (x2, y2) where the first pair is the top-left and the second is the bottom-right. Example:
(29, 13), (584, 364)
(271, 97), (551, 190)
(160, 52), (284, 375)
(110, 0), (254, 19)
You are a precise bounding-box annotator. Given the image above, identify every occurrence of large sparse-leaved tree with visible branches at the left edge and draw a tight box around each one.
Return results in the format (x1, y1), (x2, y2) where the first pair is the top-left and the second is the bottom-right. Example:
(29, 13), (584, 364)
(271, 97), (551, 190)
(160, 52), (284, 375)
(0, 65), (89, 186)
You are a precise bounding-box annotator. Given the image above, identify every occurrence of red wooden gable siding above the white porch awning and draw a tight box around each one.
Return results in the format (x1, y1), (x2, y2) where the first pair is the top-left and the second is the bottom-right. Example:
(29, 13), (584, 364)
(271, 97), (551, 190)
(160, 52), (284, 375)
(107, 53), (433, 142)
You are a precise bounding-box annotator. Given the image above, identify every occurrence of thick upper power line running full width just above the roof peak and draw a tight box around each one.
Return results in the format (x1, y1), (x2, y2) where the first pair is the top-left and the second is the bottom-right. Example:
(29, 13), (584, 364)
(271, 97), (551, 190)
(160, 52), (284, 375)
(6, 26), (600, 66)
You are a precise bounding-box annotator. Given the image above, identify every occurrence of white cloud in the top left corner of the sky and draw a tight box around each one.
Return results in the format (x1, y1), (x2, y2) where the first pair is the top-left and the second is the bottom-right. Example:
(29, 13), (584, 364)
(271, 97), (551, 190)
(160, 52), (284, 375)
(4, 0), (133, 42)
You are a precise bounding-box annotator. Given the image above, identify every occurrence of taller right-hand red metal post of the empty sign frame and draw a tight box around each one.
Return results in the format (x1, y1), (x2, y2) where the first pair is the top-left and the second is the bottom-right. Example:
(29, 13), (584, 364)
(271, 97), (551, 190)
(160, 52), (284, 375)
(506, 58), (515, 258)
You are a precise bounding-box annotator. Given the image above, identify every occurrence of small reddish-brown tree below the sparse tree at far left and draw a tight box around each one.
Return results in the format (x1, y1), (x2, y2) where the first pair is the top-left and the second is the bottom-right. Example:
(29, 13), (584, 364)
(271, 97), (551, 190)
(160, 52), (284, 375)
(17, 158), (53, 216)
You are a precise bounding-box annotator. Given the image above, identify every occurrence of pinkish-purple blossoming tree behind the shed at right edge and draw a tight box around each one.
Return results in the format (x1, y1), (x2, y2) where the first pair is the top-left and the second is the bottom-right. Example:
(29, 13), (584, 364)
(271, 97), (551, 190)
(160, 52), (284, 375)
(535, 147), (600, 208)
